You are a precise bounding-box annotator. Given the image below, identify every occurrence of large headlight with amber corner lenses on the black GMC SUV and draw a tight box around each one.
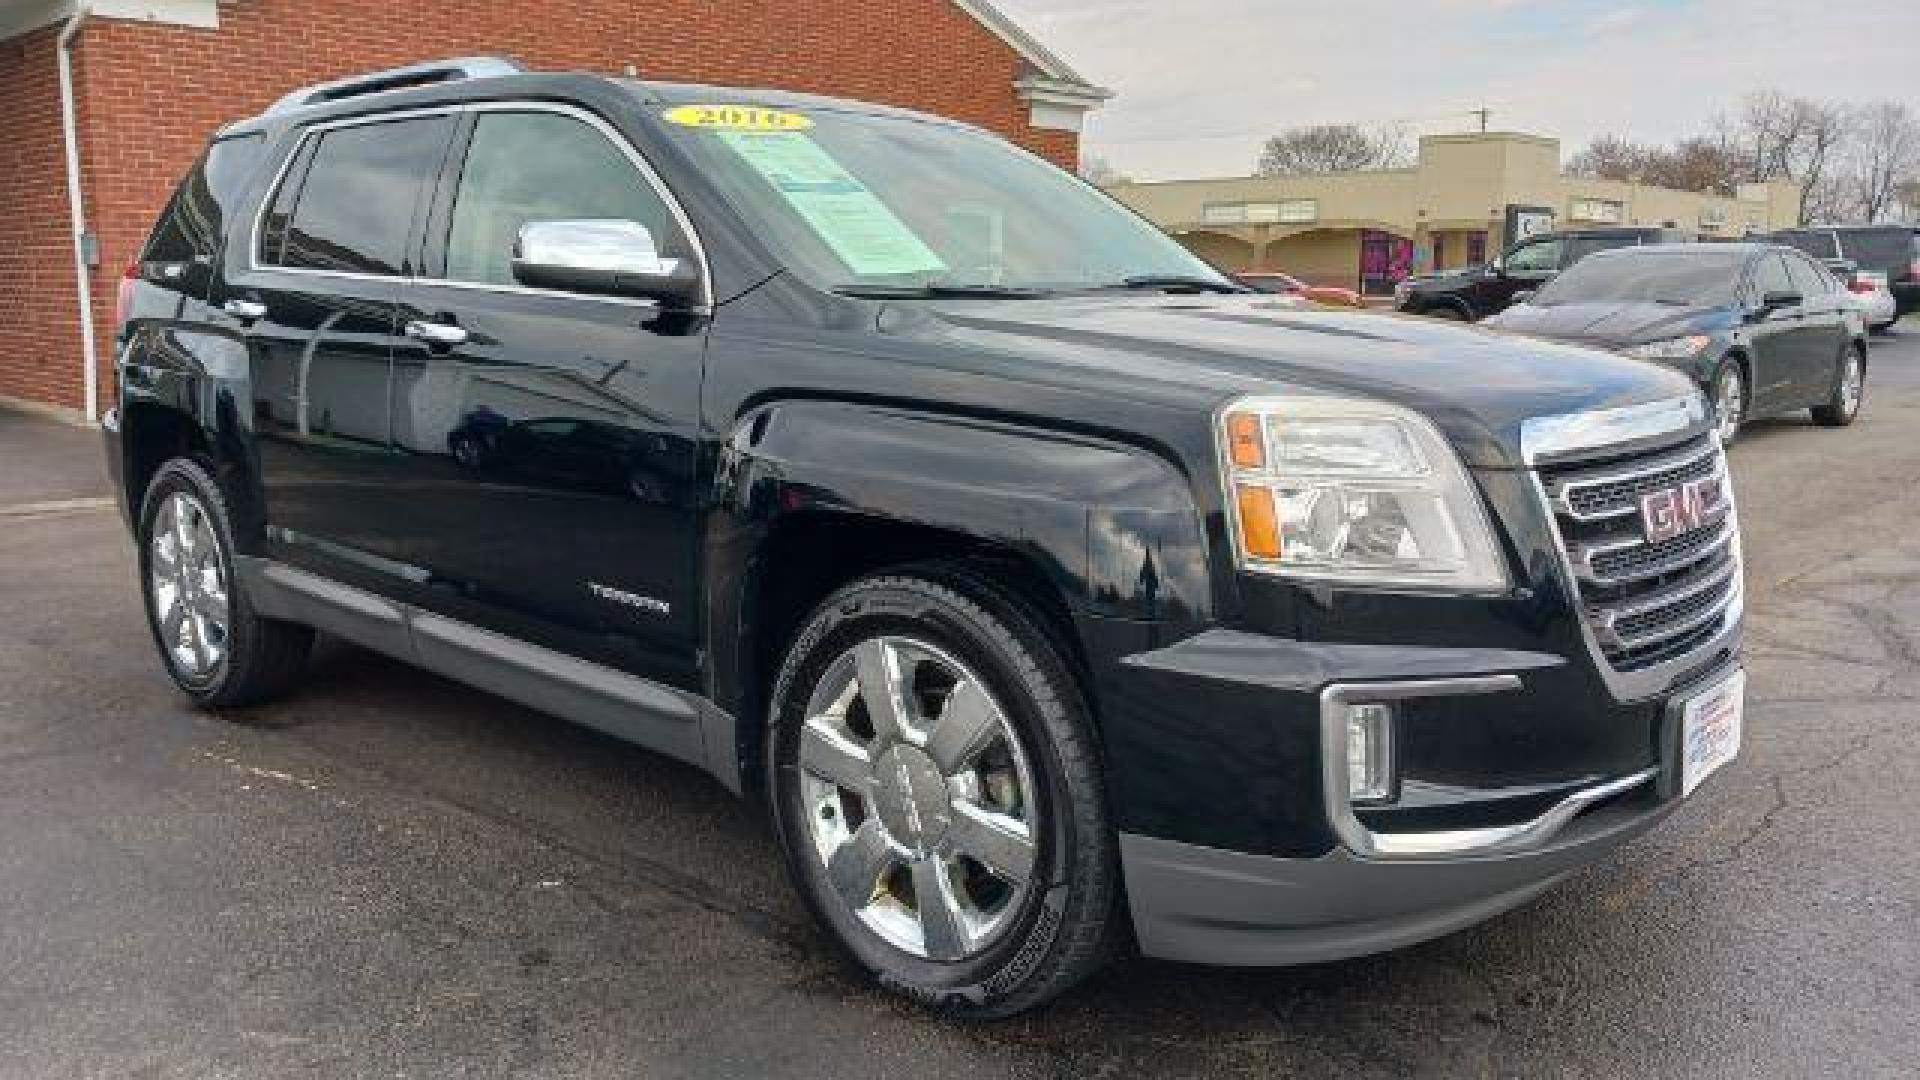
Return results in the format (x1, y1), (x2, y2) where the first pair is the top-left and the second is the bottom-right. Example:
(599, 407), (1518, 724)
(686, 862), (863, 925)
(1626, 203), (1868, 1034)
(1219, 398), (1507, 592)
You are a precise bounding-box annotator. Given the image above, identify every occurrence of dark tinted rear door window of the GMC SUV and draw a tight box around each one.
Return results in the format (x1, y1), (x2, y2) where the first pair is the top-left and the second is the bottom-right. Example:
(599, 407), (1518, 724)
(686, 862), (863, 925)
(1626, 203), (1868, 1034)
(259, 117), (453, 275)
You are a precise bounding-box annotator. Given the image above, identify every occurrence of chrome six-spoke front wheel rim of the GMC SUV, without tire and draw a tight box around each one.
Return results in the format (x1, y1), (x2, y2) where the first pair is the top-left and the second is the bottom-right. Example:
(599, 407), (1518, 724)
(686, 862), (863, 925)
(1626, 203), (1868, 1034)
(799, 636), (1041, 961)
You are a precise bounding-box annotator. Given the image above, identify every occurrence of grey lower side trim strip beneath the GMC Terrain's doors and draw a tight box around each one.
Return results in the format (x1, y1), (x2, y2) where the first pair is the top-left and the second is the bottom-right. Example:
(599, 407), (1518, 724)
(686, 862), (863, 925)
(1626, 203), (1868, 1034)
(236, 557), (741, 794)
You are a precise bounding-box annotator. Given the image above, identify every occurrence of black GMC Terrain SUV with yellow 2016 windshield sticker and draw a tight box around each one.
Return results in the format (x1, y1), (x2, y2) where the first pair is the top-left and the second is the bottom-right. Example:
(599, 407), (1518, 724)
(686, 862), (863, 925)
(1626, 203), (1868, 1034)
(108, 60), (1743, 1017)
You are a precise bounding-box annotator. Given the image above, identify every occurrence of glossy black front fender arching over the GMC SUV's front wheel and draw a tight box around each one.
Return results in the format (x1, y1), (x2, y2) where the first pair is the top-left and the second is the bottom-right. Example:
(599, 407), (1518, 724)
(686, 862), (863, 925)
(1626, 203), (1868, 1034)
(705, 402), (1212, 786)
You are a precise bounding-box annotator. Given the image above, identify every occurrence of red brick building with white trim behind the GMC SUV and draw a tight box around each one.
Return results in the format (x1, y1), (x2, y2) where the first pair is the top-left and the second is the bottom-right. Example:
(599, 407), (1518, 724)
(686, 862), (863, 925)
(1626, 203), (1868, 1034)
(0, 0), (1108, 419)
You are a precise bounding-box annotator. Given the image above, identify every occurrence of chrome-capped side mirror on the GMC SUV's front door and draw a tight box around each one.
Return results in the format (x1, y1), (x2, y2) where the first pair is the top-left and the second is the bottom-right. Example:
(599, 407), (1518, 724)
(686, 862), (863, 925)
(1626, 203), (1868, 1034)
(513, 219), (701, 307)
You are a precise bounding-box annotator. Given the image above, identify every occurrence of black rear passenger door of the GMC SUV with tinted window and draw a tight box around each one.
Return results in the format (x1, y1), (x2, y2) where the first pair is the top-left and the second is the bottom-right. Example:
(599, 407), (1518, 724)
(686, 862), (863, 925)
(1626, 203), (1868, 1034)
(209, 115), (455, 592)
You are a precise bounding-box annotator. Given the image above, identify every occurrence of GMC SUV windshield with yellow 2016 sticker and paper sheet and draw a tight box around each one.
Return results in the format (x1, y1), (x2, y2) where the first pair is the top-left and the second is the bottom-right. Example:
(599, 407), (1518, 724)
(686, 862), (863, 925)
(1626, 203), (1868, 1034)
(664, 106), (1233, 292)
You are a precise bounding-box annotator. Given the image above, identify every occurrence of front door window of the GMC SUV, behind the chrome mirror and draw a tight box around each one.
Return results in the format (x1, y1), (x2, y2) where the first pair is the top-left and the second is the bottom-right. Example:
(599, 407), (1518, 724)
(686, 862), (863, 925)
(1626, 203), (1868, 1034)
(445, 111), (684, 284)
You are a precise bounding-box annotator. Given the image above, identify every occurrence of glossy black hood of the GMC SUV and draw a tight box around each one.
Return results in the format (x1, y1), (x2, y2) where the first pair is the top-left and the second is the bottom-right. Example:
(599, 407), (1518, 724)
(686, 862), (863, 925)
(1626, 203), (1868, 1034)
(881, 296), (1692, 469)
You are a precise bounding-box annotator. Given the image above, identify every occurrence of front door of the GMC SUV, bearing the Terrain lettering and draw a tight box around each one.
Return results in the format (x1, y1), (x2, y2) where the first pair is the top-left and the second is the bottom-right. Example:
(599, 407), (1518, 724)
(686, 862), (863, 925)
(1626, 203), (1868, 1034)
(382, 106), (707, 688)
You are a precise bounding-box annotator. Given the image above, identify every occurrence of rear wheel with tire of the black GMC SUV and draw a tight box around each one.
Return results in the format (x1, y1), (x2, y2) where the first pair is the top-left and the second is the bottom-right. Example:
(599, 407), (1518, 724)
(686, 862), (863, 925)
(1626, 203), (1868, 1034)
(138, 457), (313, 709)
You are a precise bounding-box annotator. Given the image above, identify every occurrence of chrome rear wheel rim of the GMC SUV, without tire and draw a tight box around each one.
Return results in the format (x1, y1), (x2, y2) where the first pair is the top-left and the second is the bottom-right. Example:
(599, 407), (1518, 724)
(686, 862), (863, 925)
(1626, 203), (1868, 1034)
(148, 492), (230, 678)
